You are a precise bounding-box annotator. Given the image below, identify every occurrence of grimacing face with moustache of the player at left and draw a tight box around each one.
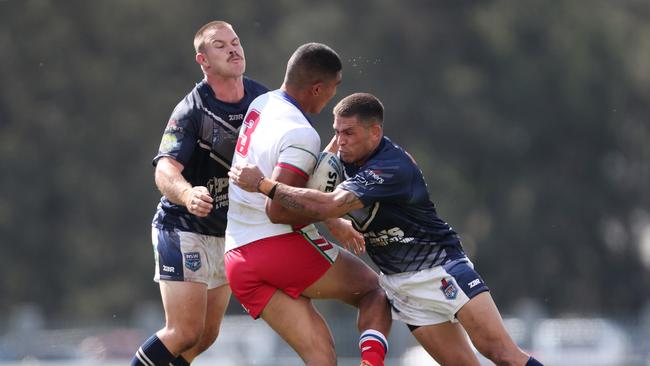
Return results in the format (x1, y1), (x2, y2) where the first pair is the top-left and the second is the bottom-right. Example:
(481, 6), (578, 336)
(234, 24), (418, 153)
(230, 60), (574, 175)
(197, 27), (246, 78)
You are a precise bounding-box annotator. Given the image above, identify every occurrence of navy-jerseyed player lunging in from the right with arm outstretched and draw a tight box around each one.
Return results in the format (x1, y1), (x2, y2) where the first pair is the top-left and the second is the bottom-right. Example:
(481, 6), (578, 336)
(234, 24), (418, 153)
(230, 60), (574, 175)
(230, 93), (541, 366)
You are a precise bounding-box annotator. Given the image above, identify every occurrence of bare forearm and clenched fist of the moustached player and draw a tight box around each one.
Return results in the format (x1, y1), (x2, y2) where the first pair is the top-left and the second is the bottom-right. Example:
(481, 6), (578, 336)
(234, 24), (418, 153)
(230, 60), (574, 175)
(155, 156), (212, 217)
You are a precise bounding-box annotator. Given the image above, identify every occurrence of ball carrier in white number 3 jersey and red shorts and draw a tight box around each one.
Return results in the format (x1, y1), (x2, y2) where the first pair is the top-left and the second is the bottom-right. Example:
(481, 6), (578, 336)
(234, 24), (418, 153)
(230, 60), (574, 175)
(225, 43), (391, 366)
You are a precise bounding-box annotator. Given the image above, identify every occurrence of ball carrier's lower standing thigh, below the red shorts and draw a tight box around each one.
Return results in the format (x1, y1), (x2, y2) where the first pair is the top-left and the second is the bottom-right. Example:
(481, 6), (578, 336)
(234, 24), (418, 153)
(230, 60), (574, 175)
(261, 291), (336, 364)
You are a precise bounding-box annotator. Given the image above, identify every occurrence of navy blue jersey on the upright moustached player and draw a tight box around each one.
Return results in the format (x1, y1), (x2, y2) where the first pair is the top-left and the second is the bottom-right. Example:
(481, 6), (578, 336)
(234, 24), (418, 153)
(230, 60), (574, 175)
(153, 78), (268, 236)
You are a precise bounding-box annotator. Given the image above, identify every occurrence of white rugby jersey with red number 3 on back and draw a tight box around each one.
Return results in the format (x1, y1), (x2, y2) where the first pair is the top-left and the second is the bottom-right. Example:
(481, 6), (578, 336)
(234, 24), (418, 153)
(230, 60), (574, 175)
(226, 90), (320, 251)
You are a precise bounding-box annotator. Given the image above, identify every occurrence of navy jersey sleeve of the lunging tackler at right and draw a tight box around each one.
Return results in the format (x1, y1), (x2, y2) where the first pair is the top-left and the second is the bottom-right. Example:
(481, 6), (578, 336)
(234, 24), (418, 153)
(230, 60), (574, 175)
(337, 164), (412, 207)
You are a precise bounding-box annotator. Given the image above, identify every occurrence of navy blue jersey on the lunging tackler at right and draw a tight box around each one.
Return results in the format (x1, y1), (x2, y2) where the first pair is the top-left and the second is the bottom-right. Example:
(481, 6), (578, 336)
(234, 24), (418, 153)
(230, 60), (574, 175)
(339, 137), (465, 274)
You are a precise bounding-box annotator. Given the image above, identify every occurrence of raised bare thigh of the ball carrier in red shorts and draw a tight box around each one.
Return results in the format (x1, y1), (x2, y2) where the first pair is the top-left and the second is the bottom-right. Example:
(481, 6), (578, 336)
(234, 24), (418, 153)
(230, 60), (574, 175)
(303, 249), (379, 305)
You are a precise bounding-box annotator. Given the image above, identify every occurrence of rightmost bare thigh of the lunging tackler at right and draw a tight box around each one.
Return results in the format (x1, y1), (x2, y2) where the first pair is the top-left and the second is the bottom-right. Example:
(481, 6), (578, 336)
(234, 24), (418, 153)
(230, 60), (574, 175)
(456, 292), (517, 354)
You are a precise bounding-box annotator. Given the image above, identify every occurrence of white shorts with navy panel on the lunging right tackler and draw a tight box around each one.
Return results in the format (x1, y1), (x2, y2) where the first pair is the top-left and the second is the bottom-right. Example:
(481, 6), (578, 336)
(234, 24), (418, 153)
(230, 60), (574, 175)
(379, 258), (489, 326)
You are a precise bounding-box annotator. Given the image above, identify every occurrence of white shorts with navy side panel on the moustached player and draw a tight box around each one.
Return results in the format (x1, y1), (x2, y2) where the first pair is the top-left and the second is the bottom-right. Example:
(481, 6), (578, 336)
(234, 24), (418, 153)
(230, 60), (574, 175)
(151, 227), (228, 289)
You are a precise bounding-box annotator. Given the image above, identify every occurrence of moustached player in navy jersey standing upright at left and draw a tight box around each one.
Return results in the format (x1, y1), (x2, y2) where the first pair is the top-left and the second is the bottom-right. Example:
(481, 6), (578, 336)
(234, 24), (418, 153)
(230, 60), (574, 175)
(131, 21), (268, 366)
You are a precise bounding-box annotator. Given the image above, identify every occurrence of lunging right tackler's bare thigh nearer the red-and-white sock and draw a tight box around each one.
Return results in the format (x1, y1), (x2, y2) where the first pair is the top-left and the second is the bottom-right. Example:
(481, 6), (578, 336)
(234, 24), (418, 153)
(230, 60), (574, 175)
(413, 322), (480, 366)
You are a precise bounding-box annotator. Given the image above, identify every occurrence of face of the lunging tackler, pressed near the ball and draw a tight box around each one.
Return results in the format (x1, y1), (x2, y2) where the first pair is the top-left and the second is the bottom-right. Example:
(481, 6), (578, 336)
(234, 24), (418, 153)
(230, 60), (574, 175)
(334, 116), (381, 164)
